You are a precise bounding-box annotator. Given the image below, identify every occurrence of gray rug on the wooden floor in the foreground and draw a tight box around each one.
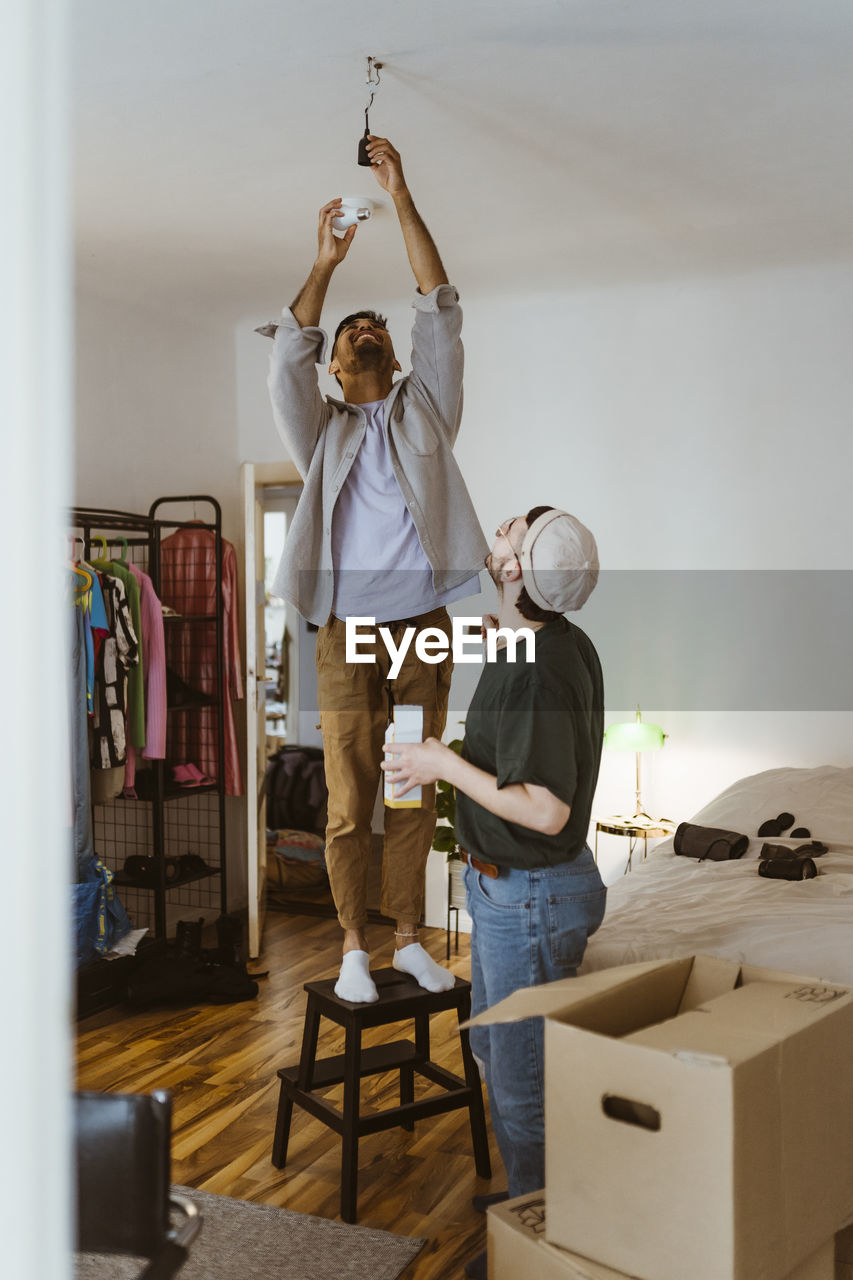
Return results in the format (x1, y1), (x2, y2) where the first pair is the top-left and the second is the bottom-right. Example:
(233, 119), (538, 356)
(74, 1187), (427, 1280)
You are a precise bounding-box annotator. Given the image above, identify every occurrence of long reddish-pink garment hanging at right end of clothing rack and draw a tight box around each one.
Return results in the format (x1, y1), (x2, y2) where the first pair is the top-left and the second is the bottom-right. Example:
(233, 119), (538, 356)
(160, 526), (243, 796)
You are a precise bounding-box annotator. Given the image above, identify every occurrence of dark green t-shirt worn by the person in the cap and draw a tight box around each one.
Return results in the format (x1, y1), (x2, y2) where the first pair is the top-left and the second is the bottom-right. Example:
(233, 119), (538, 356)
(456, 618), (605, 869)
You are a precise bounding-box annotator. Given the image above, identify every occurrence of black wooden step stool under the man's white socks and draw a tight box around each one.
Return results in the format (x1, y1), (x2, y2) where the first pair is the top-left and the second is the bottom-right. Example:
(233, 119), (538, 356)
(273, 969), (492, 1222)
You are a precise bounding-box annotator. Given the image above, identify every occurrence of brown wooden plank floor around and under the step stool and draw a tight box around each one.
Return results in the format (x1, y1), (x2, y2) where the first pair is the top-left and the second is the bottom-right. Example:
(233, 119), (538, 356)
(77, 913), (506, 1280)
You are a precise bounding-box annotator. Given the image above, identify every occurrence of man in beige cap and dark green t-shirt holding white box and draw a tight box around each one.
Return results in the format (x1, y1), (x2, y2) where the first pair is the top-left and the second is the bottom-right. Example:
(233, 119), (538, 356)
(383, 507), (606, 1275)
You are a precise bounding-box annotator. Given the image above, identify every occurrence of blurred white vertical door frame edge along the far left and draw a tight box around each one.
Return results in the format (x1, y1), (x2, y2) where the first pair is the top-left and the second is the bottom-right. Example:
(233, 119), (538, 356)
(0, 0), (72, 1280)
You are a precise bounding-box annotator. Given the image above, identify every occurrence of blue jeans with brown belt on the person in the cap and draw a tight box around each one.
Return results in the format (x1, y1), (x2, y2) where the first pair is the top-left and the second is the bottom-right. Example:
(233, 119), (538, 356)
(465, 847), (607, 1196)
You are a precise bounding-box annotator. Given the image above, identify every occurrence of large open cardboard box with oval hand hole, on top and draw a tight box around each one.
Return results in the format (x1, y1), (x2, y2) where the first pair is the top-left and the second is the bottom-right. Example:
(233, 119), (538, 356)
(473, 956), (853, 1280)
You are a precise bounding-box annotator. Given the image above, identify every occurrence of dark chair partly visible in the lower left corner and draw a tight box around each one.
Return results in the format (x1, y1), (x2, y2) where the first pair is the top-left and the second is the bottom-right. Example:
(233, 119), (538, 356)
(74, 1091), (201, 1280)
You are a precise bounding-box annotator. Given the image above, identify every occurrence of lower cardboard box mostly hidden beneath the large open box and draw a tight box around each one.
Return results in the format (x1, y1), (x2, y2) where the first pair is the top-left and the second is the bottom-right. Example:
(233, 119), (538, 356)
(488, 1192), (835, 1280)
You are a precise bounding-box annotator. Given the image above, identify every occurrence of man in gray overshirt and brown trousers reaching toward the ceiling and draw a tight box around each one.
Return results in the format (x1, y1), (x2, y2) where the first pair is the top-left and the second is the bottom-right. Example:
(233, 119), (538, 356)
(262, 136), (487, 1002)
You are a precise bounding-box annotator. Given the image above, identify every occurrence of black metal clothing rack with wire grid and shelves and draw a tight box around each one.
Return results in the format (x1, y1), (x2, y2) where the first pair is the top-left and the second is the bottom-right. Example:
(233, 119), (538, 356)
(68, 494), (228, 937)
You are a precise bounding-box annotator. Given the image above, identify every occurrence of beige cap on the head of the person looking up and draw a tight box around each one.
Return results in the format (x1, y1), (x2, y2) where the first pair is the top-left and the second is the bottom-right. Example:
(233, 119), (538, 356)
(519, 509), (598, 613)
